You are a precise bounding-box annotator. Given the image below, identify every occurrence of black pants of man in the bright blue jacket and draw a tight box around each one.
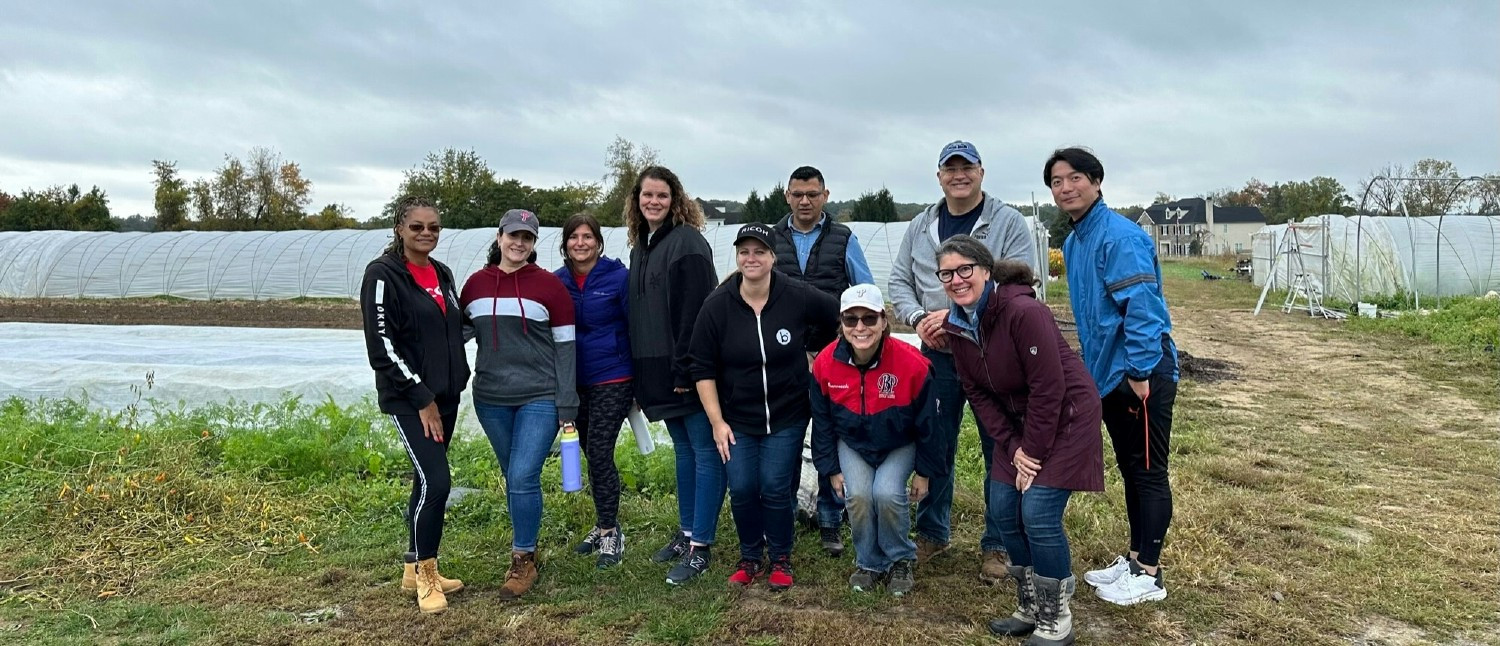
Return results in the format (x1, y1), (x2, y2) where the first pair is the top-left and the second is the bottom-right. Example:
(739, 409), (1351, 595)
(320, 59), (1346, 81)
(1104, 375), (1178, 565)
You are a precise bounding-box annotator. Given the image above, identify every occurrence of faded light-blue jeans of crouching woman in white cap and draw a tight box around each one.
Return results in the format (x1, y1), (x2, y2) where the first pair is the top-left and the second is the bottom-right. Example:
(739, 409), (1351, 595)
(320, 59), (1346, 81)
(839, 441), (917, 573)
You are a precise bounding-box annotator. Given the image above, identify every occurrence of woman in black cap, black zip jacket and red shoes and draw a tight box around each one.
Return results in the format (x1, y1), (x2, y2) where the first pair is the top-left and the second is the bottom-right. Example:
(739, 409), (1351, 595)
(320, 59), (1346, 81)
(690, 223), (839, 589)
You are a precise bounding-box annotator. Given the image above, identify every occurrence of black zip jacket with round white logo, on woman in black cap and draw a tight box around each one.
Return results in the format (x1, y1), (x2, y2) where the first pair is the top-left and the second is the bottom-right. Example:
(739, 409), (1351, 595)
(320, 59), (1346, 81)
(692, 271), (839, 435)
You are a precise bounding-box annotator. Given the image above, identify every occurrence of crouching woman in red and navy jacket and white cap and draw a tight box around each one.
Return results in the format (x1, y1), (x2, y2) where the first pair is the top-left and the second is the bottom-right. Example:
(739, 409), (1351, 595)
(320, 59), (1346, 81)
(810, 285), (948, 597)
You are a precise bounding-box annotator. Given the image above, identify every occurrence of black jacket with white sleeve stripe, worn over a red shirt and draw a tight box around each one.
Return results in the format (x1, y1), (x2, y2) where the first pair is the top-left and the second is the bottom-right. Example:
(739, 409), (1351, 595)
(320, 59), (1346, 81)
(360, 253), (470, 415)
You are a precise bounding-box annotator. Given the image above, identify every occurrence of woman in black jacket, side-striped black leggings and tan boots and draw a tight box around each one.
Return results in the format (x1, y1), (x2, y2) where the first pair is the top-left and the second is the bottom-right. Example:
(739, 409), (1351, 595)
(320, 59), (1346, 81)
(360, 196), (470, 613)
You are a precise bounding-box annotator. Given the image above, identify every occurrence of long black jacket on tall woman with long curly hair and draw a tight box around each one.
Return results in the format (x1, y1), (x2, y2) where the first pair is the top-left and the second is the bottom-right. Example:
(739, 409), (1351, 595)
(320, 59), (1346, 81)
(629, 220), (719, 420)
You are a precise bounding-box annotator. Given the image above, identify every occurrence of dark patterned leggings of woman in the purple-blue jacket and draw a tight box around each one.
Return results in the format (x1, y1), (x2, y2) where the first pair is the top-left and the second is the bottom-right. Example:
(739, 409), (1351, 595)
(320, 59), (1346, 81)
(573, 381), (635, 529)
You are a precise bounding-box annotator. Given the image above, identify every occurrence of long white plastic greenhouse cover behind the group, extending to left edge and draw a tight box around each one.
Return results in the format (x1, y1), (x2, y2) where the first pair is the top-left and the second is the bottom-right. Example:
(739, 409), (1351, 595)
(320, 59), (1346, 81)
(0, 217), (1047, 300)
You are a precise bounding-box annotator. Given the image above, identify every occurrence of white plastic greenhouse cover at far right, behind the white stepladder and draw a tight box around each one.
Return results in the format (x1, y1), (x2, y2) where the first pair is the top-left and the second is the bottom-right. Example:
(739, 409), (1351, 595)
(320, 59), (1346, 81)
(1253, 214), (1500, 301)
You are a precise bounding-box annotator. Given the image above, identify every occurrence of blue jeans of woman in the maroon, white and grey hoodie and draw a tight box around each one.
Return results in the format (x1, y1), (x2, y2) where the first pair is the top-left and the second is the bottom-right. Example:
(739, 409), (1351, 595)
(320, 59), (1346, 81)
(474, 399), (558, 552)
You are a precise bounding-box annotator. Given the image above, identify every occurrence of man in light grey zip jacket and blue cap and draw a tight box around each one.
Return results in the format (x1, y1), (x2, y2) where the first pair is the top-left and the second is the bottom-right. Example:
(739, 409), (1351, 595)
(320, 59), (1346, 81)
(888, 141), (1037, 583)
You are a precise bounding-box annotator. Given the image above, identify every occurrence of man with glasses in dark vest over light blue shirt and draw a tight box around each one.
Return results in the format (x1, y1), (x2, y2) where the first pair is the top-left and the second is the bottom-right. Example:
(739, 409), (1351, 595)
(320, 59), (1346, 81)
(776, 166), (875, 556)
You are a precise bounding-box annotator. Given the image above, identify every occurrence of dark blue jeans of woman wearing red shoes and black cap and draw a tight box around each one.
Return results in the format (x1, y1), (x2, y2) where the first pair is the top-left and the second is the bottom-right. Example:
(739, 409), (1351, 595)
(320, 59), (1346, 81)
(725, 426), (807, 561)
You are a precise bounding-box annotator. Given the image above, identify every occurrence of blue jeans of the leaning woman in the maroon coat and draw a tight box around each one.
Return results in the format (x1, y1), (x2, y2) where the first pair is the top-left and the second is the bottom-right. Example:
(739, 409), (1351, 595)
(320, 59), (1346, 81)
(984, 480), (1073, 580)
